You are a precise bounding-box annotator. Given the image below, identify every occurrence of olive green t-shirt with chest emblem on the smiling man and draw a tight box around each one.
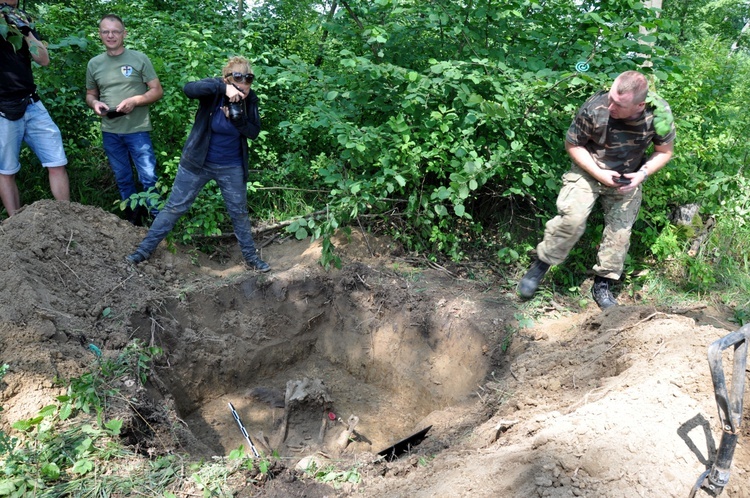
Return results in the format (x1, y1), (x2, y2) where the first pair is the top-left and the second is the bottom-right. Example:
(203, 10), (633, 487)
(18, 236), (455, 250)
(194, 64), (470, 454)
(86, 48), (157, 133)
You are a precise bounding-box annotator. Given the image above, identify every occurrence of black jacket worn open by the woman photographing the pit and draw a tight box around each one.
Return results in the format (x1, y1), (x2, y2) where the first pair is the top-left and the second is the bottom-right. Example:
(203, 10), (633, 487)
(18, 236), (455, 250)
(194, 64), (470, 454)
(180, 78), (260, 181)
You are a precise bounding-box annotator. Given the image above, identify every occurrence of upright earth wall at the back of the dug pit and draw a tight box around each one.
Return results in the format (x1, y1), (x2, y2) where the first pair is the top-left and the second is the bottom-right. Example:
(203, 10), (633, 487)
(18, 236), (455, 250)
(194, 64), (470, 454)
(131, 265), (488, 416)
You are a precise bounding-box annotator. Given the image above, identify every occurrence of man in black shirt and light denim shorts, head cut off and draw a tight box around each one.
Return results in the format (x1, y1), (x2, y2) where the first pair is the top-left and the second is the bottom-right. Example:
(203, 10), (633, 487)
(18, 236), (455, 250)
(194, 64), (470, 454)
(0, 0), (70, 216)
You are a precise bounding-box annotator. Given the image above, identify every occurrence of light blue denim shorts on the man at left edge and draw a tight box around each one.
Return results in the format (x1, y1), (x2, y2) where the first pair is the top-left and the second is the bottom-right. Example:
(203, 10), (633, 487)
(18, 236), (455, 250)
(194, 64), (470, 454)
(0, 101), (68, 175)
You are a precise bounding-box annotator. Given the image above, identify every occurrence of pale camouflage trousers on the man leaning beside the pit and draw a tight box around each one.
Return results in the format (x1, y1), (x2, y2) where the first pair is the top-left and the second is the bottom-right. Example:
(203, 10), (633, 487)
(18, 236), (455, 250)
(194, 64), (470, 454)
(536, 165), (642, 280)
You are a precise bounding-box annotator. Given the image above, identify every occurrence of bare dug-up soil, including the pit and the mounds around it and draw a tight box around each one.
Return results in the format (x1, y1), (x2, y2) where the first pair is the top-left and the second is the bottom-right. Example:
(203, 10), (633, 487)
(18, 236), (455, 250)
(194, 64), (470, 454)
(0, 201), (750, 498)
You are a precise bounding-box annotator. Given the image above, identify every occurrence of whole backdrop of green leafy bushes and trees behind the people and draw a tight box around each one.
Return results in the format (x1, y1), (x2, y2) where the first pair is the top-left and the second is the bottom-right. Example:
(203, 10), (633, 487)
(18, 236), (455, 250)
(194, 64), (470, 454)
(7, 0), (750, 296)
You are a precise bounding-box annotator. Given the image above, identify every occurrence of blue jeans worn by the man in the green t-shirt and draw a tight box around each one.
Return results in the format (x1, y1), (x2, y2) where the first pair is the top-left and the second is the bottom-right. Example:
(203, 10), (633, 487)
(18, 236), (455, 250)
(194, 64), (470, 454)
(102, 131), (156, 200)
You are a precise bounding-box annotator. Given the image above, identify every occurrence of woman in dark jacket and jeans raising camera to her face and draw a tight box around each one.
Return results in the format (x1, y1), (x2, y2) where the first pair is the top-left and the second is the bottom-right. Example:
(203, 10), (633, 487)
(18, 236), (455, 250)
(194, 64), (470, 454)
(127, 57), (271, 272)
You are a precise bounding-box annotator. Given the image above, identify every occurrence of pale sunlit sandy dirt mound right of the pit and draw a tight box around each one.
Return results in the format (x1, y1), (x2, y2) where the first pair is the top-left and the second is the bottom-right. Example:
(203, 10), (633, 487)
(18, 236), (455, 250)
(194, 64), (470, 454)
(368, 307), (750, 498)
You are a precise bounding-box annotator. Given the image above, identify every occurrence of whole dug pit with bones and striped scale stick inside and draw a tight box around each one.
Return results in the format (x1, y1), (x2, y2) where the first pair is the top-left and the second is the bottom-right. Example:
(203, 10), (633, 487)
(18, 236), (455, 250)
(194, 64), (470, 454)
(132, 262), (500, 457)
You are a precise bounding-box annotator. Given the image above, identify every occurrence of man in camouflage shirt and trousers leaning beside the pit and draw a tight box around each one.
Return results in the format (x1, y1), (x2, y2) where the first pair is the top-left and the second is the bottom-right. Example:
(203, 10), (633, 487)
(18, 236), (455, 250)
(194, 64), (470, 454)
(518, 71), (675, 309)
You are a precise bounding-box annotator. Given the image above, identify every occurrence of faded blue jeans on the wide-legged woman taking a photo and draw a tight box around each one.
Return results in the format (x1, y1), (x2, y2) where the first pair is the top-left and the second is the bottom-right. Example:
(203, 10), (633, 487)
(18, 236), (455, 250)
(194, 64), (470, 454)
(136, 163), (256, 261)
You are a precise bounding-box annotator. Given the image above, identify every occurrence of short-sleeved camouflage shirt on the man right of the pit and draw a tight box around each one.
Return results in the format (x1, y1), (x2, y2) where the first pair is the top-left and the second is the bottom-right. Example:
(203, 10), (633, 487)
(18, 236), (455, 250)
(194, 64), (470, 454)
(565, 91), (675, 173)
